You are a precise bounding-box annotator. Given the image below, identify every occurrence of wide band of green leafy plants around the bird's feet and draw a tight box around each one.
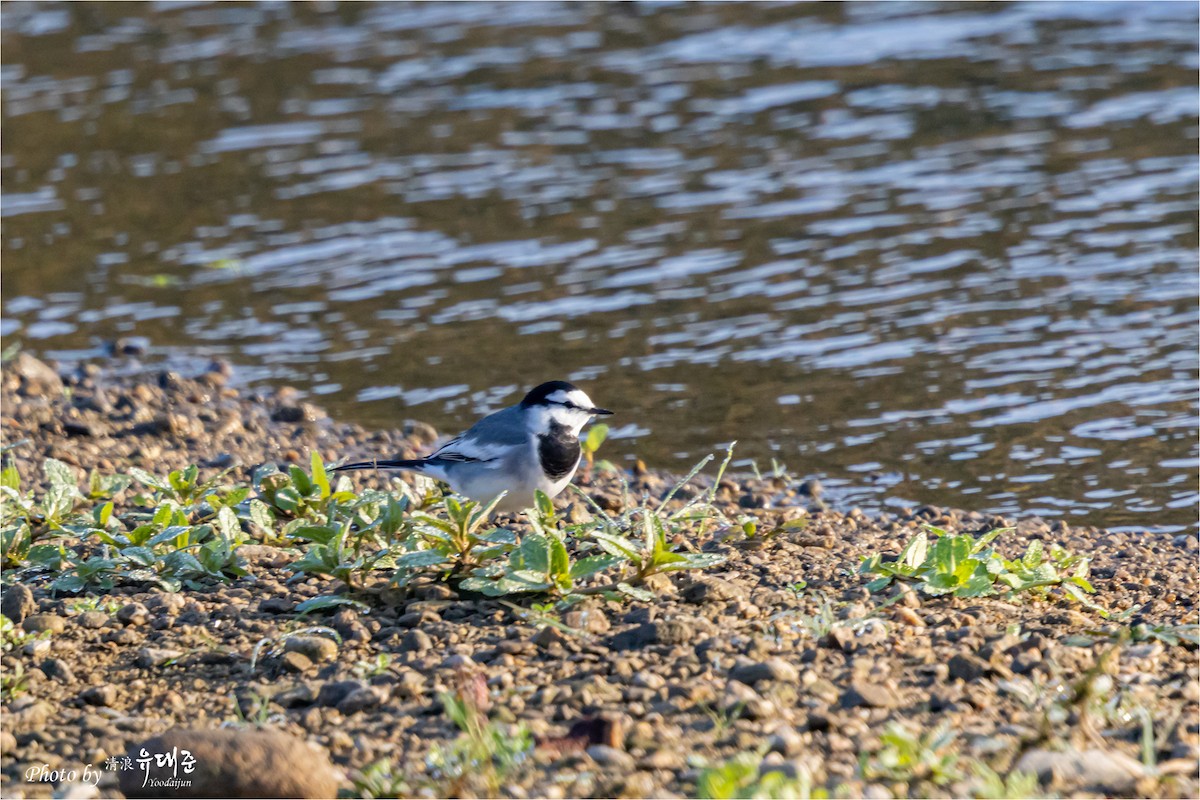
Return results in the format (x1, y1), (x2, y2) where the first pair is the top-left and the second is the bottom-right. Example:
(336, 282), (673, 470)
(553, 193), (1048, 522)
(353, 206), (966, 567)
(0, 443), (732, 613)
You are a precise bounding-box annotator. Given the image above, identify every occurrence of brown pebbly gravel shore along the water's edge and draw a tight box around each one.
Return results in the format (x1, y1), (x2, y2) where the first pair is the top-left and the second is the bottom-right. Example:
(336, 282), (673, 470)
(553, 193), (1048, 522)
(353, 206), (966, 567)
(0, 355), (1200, 798)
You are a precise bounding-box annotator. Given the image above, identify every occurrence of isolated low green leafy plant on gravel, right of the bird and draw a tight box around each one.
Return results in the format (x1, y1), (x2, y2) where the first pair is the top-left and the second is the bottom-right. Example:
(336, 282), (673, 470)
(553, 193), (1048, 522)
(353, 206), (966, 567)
(859, 525), (1103, 610)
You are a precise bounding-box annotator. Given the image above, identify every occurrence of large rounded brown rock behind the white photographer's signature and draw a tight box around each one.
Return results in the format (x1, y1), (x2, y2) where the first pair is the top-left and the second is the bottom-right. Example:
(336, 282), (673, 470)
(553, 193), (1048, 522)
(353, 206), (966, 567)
(120, 728), (340, 798)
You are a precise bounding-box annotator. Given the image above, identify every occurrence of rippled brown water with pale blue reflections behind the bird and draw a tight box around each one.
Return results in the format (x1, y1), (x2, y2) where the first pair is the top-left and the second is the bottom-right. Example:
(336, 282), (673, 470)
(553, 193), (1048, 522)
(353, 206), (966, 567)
(0, 1), (1200, 530)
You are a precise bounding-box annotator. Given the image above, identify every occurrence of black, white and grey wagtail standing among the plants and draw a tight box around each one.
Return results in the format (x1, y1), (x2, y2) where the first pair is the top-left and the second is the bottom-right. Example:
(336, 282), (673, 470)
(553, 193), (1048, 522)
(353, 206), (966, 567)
(334, 380), (612, 512)
